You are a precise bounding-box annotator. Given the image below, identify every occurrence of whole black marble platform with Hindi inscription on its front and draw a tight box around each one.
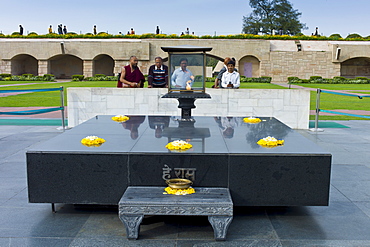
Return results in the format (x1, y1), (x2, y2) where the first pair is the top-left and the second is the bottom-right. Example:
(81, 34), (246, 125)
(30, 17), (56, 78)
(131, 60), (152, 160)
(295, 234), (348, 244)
(26, 116), (331, 206)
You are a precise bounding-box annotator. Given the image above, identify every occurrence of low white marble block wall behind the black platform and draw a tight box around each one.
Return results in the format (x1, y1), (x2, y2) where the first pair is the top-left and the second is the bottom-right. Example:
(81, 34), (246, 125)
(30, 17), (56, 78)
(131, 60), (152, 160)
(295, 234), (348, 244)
(67, 87), (310, 129)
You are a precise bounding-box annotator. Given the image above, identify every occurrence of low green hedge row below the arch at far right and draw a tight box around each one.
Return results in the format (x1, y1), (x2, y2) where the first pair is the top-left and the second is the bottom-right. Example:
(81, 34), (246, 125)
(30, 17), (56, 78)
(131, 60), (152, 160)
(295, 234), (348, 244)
(288, 76), (370, 84)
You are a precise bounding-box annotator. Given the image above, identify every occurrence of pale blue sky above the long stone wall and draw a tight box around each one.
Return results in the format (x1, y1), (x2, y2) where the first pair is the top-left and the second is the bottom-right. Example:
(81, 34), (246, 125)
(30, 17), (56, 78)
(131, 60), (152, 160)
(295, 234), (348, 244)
(0, 0), (370, 37)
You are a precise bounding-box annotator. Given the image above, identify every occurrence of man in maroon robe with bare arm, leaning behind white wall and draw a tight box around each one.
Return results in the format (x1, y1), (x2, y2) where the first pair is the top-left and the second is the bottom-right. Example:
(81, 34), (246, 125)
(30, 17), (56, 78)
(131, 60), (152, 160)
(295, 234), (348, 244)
(117, 56), (145, 88)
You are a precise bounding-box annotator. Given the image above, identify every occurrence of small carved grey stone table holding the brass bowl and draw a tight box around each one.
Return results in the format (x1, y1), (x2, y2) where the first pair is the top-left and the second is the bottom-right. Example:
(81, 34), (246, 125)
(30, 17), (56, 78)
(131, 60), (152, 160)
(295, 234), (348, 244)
(119, 186), (233, 240)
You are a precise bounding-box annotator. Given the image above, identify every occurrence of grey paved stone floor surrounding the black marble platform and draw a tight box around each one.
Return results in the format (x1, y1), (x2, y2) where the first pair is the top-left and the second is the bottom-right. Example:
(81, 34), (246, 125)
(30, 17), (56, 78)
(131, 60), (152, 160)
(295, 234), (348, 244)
(0, 121), (370, 247)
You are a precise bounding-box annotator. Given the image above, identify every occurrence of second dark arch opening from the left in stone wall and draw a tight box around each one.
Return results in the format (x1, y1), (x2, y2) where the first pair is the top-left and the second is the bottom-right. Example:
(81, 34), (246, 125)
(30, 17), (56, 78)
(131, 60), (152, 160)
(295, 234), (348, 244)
(49, 54), (83, 79)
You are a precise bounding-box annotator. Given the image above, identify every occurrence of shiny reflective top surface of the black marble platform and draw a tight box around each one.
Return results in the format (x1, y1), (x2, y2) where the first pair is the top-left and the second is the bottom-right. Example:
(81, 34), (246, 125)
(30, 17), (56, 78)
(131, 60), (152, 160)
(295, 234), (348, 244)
(30, 116), (329, 155)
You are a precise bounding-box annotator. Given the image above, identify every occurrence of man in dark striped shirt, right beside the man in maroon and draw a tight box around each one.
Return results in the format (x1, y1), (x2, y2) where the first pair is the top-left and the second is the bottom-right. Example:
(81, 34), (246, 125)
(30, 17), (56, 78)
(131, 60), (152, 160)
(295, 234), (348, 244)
(148, 57), (168, 88)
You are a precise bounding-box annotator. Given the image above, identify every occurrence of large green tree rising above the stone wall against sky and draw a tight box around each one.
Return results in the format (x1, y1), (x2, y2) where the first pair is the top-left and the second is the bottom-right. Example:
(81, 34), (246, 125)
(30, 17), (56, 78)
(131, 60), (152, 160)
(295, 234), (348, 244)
(243, 0), (307, 35)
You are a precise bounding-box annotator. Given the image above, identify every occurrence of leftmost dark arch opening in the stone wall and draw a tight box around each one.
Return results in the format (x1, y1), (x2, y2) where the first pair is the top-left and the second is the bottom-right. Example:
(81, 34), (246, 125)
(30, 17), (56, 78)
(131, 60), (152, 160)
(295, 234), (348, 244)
(11, 54), (38, 75)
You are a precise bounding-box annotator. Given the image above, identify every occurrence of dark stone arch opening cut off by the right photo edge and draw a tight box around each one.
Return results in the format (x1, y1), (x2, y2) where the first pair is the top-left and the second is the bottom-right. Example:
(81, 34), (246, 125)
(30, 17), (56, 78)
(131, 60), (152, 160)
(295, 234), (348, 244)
(340, 57), (370, 78)
